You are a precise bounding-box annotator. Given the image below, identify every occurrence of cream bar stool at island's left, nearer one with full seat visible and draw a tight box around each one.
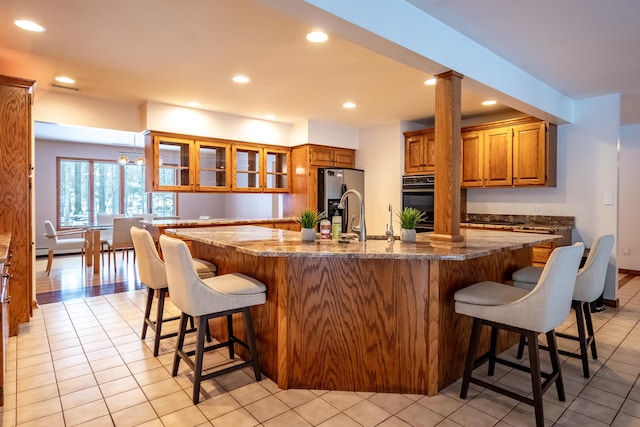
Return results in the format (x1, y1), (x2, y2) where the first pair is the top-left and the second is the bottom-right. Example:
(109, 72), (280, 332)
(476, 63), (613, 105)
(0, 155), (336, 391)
(160, 234), (267, 404)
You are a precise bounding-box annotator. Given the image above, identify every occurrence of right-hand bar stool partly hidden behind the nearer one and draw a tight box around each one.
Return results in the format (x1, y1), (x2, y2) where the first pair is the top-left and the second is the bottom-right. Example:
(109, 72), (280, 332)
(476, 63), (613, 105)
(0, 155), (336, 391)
(511, 234), (615, 378)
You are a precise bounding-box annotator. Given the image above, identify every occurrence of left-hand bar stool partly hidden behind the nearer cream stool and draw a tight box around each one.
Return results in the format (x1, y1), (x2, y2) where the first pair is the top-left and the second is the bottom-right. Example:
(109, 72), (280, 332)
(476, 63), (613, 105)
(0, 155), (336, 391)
(129, 227), (217, 356)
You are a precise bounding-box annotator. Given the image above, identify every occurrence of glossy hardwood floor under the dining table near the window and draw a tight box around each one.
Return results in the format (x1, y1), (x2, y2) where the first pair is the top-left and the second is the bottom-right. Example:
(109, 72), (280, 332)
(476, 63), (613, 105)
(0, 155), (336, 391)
(35, 250), (144, 304)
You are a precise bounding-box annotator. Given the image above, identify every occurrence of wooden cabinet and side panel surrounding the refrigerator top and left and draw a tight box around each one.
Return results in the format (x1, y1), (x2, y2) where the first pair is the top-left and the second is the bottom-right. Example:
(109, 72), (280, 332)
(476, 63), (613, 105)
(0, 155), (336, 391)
(283, 144), (356, 216)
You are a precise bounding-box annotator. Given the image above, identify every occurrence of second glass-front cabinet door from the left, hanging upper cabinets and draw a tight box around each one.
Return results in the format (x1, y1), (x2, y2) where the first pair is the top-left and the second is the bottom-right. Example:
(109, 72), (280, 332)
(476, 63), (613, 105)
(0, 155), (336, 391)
(196, 141), (231, 191)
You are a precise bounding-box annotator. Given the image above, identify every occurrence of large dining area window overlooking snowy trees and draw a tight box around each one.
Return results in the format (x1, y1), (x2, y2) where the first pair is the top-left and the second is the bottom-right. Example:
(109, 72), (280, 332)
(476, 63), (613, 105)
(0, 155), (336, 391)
(57, 157), (177, 227)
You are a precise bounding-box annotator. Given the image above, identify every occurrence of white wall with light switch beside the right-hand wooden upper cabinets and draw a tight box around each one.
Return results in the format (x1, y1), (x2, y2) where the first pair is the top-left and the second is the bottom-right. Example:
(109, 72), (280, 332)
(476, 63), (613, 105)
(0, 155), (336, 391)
(467, 95), (620, 299)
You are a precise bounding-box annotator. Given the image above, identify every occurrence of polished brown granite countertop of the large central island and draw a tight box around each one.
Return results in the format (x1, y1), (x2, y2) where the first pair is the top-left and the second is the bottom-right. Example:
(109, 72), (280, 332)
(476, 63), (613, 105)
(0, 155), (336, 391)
(167, 226), (559, 261)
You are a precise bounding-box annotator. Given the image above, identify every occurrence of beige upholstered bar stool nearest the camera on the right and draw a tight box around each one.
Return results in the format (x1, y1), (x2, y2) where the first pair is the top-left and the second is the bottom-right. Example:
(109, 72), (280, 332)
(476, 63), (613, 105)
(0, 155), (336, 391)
(454, 243), (584, 427)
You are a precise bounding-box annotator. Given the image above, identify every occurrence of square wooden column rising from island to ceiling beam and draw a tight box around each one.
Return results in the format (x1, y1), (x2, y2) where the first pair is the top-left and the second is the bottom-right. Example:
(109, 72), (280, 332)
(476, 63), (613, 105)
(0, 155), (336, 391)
(431, 71), (464, 243)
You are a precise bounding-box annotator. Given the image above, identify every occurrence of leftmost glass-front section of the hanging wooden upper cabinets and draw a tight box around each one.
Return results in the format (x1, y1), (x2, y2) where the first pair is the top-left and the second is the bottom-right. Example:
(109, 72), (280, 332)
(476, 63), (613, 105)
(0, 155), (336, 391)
(145, 132), (196, 191)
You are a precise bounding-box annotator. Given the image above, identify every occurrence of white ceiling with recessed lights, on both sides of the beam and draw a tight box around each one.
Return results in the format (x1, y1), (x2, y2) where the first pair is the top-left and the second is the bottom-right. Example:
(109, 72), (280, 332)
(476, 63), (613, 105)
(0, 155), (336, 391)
(0, 0), (640, 145)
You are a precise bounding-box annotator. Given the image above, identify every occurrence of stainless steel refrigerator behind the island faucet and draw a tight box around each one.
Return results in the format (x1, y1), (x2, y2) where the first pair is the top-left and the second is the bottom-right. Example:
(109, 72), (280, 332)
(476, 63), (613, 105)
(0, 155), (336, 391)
(318, 168), (364, 233)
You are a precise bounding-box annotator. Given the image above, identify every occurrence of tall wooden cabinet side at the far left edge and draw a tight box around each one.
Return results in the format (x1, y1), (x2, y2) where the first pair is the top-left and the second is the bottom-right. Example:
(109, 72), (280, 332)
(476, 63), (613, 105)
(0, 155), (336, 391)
(0, 76), (35, 336)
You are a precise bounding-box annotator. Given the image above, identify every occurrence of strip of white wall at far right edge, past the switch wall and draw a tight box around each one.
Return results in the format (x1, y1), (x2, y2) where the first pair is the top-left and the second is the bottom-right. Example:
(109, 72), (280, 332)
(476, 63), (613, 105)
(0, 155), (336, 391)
(617, 125), (640, 271)
